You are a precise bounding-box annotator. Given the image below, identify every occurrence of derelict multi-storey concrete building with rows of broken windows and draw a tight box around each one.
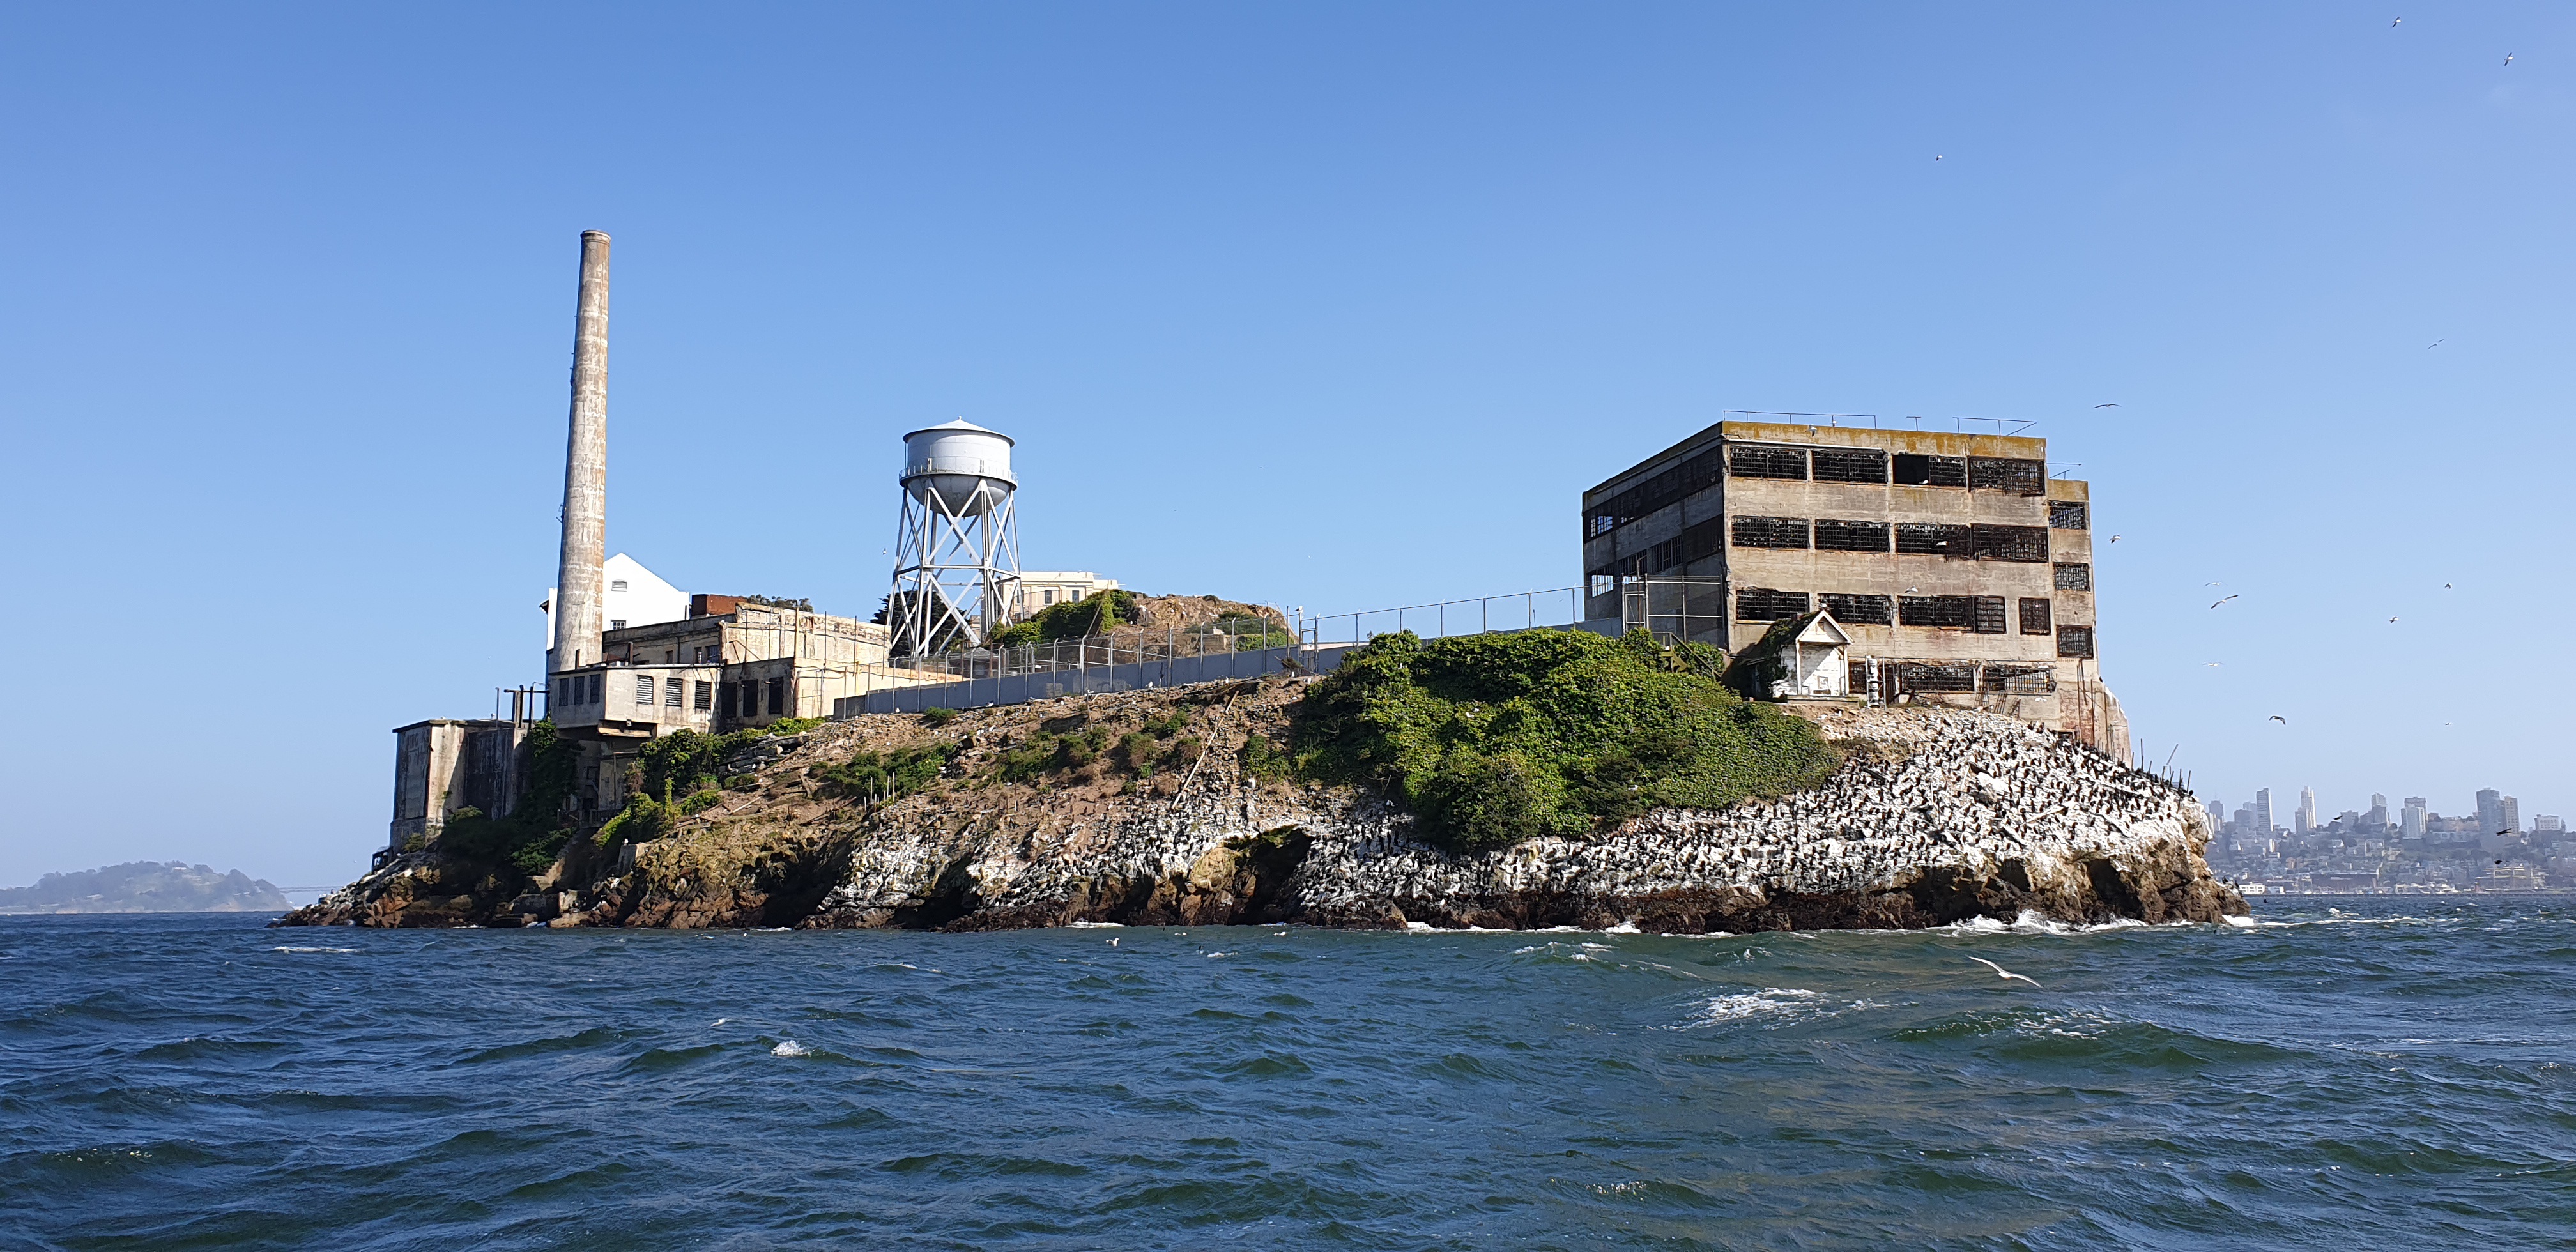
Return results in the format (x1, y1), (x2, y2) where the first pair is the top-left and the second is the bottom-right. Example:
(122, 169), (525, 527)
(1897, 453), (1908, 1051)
(1582, 420), (2128, 755)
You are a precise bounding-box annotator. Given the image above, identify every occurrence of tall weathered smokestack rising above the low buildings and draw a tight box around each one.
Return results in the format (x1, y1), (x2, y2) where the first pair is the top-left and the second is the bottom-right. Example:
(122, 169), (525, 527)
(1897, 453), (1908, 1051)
(546, 229), (608, 673)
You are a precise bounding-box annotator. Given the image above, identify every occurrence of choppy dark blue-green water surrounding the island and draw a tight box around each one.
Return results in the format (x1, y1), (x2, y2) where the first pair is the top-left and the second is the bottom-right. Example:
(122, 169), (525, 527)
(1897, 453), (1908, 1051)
(0, 899), (2576, 1249)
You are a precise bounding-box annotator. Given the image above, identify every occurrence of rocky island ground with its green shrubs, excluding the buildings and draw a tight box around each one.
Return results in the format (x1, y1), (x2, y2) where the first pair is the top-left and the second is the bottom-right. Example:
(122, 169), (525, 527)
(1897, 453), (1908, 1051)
(280, 631), (2246, 933)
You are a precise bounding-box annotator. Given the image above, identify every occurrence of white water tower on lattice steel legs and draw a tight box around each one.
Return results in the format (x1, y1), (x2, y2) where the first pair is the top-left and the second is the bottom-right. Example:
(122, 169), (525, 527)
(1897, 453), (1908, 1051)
(886, 417), (1020, 657)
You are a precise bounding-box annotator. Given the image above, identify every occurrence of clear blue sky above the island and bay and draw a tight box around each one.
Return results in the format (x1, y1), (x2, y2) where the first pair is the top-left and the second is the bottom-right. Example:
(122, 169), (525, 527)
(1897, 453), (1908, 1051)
(0, 3), (2576, 886)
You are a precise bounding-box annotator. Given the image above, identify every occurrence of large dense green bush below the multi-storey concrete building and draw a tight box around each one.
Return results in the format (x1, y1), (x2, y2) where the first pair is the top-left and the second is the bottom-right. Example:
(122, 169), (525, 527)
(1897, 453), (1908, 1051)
(1298, 631), (1839, 850)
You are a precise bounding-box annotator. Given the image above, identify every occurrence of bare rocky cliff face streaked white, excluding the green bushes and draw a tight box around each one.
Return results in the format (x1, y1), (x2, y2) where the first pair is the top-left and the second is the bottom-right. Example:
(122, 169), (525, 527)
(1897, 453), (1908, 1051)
(291, 680), (2244, 933)
